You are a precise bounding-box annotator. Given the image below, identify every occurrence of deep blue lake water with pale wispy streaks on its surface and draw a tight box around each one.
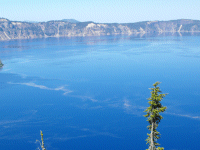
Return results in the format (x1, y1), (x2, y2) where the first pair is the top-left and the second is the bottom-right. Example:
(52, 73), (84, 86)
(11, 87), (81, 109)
(0, 36), (200, 150)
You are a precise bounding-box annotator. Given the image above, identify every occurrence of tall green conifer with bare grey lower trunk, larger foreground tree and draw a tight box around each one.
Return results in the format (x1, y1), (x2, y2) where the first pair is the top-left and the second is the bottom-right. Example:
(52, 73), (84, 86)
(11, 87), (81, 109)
(144, 82), (167, 150)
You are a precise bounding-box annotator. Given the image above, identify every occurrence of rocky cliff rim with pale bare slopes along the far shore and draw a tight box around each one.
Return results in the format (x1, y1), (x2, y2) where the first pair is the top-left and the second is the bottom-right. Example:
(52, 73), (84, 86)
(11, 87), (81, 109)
(0, 18), (200, 41)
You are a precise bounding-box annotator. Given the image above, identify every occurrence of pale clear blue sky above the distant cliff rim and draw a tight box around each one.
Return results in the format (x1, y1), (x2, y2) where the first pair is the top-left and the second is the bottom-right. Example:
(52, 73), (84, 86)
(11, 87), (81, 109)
(0, 0), (200, 23)
